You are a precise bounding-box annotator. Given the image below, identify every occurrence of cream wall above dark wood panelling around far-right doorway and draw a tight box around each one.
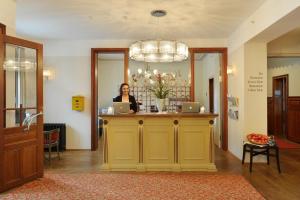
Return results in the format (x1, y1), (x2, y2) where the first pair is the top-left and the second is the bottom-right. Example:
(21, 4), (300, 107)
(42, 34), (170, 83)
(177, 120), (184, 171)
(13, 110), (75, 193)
(268, 57), (300, 97)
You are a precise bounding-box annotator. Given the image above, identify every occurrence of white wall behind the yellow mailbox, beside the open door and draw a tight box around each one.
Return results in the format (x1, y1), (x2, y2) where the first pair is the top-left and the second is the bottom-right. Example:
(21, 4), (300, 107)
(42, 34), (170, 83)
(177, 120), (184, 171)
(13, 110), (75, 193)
(44, 56), (91, 149)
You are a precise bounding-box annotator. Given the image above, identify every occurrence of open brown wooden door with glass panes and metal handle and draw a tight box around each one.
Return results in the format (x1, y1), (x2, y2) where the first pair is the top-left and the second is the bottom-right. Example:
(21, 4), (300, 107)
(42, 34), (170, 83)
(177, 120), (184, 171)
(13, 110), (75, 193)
(0, 34), (43, 192)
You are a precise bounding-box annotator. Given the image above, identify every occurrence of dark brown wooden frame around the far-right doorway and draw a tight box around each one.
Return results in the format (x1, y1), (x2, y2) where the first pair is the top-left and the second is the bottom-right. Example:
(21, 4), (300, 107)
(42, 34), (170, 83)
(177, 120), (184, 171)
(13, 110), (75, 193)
(272, 74), (289, 137)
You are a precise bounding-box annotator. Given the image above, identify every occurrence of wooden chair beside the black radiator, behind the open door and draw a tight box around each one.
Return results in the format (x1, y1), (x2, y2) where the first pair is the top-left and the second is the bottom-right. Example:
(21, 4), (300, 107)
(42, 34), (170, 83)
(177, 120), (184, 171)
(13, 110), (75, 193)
(44, 128), (60, 164)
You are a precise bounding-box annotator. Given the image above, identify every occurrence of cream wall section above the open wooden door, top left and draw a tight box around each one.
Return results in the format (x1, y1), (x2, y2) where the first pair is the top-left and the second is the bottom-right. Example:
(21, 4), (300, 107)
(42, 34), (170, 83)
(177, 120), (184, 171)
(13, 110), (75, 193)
(0, 0), (16, 36)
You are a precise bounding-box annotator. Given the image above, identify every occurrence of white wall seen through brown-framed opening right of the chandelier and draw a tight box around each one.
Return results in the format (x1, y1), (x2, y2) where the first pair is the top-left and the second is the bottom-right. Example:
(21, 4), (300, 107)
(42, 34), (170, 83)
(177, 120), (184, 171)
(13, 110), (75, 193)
(195, 53), (221, 146)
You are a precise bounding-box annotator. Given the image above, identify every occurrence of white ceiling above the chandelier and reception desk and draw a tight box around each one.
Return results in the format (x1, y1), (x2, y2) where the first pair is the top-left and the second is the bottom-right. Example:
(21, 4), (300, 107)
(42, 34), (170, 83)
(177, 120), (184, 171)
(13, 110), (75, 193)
(16, 0), (265, 40)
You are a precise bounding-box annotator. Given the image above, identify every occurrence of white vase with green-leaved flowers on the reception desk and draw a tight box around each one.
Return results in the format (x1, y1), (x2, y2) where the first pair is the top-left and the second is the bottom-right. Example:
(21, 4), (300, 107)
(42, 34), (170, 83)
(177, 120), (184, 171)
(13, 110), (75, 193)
(149, 74), (171, 112)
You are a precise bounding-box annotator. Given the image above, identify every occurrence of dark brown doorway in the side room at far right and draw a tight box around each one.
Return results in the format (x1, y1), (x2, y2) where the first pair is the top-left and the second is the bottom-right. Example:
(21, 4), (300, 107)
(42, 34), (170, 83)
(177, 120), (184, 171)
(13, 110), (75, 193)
(273, 74), (288, 138)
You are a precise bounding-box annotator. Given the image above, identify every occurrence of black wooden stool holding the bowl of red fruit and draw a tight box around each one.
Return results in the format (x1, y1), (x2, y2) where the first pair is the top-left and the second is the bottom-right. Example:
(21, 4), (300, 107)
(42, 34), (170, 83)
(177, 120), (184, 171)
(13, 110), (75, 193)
(242, 142), (281, 173)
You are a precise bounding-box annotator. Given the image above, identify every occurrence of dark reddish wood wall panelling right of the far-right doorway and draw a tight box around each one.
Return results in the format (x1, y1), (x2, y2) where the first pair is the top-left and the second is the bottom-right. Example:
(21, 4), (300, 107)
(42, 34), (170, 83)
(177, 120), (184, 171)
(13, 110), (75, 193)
(287, 97), (300, 142)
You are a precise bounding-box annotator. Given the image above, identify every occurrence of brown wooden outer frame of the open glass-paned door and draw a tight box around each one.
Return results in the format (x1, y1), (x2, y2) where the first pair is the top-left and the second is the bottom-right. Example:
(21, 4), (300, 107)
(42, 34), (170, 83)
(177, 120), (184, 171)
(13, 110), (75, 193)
(0, 34), (44, 192)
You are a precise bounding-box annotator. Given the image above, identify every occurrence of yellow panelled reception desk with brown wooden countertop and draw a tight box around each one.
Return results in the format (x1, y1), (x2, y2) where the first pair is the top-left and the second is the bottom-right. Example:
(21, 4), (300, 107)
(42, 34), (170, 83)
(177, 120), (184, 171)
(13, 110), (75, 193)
(99, 113), (217, 171)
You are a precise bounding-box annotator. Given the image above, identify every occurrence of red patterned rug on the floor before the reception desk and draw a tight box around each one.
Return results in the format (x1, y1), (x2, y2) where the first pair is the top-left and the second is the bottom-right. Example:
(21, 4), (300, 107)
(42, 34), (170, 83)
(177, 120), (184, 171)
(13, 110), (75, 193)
(0, 172), (264, 200)
